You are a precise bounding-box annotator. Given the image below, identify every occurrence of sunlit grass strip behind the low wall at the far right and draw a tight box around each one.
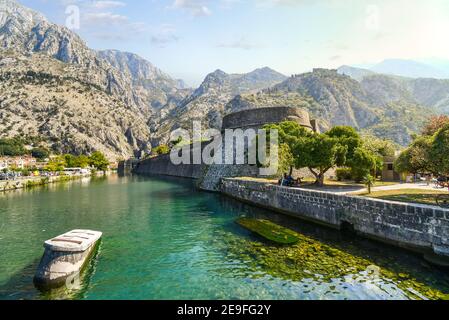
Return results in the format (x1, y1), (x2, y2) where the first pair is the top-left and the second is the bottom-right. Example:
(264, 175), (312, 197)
(357, 189), (449, 205)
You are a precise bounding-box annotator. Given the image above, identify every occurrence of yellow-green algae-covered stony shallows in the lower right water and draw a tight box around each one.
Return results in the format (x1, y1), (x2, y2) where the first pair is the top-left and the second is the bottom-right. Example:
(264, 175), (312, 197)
(225, 224), (449, 300)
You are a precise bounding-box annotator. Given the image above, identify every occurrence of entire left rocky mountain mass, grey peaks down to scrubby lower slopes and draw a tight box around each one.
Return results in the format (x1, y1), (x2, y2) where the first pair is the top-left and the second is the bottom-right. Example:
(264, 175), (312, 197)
(0, 0), (191, 159)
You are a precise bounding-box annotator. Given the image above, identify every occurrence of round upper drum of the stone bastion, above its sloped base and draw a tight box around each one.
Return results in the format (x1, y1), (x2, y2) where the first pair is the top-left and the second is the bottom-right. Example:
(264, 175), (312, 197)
(222, 107), (319, 132)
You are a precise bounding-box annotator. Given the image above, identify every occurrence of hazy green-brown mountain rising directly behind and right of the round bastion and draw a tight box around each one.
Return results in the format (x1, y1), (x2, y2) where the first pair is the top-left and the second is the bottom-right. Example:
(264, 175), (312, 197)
(226, 69), (433, 145)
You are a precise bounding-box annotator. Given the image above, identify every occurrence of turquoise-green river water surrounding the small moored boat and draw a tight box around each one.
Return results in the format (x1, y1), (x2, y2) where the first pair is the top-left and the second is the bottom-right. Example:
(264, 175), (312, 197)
(0, 175), (449, 299)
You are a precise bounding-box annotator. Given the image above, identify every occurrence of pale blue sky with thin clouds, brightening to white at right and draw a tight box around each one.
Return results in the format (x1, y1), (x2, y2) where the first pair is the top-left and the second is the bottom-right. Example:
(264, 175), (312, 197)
(19, 0), (449, 85)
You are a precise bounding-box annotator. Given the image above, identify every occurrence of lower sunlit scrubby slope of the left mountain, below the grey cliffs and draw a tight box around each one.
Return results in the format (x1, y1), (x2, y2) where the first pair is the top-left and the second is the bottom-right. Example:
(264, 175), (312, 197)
(0, 51), (149, 160)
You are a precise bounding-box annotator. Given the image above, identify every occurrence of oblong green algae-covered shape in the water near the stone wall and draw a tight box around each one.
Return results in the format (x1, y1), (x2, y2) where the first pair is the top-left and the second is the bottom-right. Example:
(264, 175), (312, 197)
(236, 218), (299, 245)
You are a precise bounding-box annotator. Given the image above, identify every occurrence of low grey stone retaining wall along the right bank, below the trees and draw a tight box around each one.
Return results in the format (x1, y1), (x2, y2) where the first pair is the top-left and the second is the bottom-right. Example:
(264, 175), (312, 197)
(221, 179), (449, 257)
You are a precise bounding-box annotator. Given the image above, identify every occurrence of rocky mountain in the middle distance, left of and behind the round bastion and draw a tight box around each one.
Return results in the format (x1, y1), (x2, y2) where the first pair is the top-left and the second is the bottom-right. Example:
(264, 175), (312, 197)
(150, 68), (287, 143)
